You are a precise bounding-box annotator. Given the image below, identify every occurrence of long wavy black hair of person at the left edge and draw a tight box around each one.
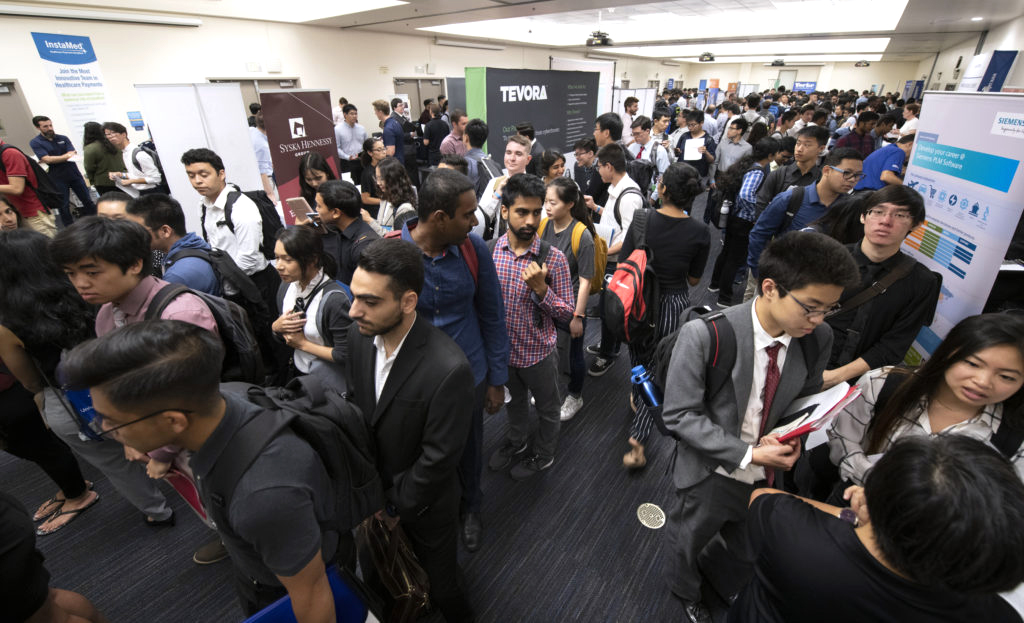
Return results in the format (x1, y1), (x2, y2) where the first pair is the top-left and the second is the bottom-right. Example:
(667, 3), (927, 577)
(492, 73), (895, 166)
(0, 230), (96, 352)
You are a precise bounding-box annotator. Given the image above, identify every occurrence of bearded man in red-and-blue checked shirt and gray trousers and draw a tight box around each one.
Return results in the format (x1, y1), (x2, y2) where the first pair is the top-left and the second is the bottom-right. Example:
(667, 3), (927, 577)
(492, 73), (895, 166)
(487, 173), (574, 481)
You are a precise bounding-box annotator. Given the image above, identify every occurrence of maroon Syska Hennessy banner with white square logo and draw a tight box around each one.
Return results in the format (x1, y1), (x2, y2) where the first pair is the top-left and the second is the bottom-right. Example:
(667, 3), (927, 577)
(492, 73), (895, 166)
(259, 89), (338, 224)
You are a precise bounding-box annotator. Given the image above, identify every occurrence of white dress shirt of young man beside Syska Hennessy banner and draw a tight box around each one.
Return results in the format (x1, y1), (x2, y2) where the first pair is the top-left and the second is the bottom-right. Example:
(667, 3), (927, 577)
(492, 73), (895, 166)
(203, 184), (268, 276)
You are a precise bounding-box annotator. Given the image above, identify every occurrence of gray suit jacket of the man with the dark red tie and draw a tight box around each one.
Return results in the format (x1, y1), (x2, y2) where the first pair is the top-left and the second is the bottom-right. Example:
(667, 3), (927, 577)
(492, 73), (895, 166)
(664, 300), (833, 489)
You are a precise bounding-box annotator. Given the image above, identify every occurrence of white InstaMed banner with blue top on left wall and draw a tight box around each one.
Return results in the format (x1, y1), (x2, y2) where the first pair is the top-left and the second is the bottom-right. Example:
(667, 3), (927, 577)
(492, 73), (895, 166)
(32, 33), (116, 152)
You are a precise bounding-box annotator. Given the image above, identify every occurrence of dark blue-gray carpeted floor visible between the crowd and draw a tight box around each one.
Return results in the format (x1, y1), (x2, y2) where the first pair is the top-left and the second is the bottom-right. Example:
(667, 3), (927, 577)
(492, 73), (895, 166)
(6, 199), (745, 623)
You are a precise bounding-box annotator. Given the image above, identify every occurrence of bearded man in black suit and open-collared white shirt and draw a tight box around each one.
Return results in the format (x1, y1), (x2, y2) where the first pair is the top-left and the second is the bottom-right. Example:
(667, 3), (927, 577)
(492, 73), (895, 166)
(347, 239), (475, 622)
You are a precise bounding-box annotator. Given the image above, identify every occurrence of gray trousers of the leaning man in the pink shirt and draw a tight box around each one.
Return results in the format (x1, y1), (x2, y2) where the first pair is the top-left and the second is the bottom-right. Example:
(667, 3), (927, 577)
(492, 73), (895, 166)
(43, 388), (172, 521)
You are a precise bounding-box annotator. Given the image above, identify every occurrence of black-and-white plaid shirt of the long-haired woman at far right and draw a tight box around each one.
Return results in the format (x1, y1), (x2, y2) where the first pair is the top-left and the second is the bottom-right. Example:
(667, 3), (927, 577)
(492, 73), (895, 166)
(827, 368), (1024, 486)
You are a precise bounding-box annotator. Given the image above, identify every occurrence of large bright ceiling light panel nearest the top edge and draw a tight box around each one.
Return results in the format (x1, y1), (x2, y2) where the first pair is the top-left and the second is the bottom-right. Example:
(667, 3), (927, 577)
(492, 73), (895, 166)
(418, 0), (908, 47)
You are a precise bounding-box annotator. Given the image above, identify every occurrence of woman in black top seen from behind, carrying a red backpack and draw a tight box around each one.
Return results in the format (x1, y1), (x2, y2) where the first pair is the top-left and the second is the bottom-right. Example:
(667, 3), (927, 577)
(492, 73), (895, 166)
(618, 162), (711, 469)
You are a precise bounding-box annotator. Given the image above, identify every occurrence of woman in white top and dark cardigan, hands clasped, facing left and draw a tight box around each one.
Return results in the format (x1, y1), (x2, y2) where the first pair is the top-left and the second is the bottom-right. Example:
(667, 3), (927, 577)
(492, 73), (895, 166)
(272, 226), (352, 378)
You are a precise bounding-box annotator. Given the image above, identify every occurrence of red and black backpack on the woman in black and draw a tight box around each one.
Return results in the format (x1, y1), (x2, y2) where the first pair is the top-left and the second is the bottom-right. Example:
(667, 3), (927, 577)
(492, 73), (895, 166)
(604, 209), (660, 345)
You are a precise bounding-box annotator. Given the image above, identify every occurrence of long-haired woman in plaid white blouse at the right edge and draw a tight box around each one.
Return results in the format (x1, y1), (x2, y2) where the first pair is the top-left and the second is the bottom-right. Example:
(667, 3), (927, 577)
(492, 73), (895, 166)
(828, 314), (1024, 485)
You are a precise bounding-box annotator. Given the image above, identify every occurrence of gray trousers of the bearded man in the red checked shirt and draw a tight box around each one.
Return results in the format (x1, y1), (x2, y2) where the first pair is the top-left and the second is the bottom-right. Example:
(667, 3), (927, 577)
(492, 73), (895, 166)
(505, 349), (562, 457)
